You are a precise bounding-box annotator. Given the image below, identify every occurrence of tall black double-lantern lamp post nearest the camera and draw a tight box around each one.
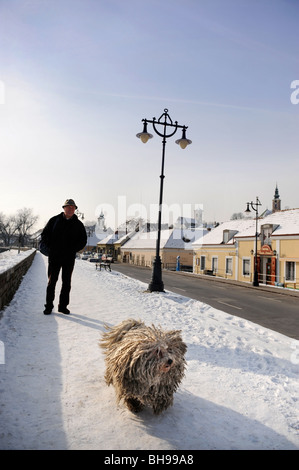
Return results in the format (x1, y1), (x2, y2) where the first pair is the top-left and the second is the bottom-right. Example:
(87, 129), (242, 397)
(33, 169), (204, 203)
(136, 109), (192, 292)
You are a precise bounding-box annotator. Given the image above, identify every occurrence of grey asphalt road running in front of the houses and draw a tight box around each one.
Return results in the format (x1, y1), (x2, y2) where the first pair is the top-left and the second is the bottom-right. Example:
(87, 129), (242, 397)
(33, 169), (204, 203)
(113, 263), (299, 340)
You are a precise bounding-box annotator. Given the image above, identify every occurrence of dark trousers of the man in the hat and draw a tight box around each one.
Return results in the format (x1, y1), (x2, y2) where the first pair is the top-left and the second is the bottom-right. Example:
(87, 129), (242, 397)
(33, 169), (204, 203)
(46, 257), (75, 308)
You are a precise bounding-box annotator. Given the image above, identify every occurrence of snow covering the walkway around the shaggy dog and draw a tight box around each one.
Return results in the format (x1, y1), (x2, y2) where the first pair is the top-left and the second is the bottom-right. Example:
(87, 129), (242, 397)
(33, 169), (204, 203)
(0, 252), (299, 450)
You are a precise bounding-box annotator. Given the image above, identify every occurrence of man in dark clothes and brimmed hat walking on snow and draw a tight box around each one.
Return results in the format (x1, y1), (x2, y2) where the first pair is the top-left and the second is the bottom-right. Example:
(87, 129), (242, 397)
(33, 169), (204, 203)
(41, 199), (87, 315)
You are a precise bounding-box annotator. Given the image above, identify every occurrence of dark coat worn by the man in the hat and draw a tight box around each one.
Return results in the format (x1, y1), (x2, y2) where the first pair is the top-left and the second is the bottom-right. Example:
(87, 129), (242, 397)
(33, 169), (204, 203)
(41, 212), (87, 258)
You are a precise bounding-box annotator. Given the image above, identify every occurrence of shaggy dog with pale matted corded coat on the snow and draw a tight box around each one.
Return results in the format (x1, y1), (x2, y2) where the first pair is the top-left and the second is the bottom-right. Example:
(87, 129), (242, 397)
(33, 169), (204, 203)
(100, 319), (187, 414)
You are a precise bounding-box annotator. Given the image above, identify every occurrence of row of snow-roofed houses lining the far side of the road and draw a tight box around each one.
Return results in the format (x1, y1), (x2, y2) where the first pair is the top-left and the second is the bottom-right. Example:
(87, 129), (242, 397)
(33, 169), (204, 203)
(97, 209), (299, 288)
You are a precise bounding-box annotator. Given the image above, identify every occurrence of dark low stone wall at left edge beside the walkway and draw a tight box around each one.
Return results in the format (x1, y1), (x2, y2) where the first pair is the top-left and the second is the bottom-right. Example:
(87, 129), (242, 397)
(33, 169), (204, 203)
(0, 251), (36, 310)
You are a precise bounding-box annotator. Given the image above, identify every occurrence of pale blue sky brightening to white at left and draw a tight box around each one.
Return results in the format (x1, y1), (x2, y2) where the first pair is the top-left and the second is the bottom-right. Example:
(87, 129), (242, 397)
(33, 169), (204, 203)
(0, 0), (299, 229)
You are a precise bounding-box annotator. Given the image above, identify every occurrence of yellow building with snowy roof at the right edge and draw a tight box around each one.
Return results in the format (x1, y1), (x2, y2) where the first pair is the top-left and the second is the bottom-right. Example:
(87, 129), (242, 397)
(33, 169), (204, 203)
(193, 209), (299, 289)
